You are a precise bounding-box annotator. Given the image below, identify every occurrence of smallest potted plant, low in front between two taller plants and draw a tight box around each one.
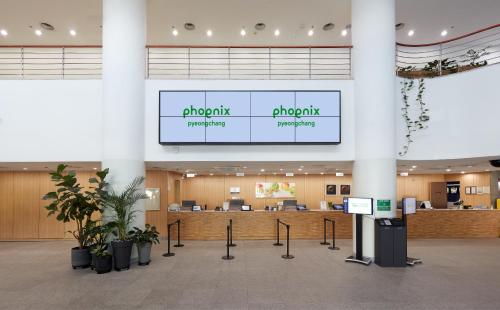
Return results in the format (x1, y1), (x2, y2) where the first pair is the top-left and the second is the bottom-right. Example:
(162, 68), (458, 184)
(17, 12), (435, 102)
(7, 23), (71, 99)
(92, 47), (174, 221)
(90, 223), (114, 274)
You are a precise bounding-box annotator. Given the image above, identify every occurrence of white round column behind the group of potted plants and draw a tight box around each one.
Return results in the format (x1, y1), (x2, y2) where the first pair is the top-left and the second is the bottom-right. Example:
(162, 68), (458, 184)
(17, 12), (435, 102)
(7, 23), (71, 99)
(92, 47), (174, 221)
(102, 0), (146, 232)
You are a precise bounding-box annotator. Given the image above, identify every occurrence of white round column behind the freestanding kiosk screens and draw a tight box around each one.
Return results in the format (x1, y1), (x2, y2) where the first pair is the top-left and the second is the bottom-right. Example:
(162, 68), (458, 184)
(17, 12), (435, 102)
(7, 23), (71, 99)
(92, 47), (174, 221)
(352, 0), (397, 257)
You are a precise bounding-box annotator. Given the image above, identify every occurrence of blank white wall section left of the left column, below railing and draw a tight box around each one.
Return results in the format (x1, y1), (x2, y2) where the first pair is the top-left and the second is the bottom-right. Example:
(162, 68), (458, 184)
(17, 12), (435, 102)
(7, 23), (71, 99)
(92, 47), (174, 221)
(0, 80), (102, 162)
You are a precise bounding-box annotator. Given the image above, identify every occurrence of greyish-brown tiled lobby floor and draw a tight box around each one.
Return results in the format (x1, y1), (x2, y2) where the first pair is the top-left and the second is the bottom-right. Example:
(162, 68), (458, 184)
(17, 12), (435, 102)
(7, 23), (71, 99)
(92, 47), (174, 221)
(0, 239), (500, 310)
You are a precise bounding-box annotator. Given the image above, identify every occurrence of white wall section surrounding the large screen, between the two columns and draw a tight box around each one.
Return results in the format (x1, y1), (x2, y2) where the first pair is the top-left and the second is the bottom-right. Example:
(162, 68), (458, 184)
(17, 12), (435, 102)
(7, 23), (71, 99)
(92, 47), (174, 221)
(145, 80), (354, 161)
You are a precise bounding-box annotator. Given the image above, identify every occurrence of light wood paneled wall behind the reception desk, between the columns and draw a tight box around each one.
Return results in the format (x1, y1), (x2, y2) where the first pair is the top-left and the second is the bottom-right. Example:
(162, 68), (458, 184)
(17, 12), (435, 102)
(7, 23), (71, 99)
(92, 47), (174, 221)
(181, 175), (352, 210)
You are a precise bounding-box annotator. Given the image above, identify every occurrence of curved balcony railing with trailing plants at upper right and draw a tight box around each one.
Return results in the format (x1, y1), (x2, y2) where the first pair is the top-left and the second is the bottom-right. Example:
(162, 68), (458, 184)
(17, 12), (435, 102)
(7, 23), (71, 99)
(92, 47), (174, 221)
(396, 24), (500, 78)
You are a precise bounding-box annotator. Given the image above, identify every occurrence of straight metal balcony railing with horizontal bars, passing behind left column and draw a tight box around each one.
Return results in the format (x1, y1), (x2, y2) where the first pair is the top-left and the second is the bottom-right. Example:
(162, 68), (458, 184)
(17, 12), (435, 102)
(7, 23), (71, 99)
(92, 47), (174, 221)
(0, 46), (351, 80)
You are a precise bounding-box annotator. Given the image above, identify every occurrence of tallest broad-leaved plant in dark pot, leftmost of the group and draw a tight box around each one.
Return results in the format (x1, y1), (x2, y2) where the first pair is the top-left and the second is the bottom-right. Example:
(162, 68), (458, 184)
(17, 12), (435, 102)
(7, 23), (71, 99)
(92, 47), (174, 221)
(43, 164), (108, 269)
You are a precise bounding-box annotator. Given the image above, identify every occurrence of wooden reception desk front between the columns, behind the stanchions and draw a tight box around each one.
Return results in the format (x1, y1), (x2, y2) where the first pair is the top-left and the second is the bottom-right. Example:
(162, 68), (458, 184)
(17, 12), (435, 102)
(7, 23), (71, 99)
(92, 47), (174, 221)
(168, 210), (352, 240)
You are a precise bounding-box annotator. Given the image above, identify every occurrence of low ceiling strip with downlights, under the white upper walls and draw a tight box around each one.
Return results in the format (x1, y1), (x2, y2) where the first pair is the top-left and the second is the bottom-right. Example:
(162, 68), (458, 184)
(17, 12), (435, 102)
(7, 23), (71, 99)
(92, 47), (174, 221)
(0, 157), (500, 175)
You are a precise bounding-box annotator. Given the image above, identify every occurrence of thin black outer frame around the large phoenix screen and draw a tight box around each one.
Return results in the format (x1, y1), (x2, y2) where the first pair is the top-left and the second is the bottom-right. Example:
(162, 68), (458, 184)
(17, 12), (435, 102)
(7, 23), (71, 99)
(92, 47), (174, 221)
(158, 89), (342, 145)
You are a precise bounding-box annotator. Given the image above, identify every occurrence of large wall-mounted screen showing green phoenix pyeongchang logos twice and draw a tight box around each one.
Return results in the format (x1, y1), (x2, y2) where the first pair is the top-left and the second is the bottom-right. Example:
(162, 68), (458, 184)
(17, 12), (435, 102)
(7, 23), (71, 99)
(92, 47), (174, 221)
(159, 91), (341, 145)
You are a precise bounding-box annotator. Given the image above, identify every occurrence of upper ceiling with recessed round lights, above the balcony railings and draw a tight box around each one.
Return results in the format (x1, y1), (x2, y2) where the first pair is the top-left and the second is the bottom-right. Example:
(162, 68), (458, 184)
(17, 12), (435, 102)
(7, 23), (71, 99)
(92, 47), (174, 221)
(0, 0), (500, 45)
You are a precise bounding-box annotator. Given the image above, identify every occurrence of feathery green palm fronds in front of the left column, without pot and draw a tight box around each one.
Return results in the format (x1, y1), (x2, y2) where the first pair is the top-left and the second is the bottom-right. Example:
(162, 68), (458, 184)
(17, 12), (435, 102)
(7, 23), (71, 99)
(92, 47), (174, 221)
(104, 177), (148, 241)
